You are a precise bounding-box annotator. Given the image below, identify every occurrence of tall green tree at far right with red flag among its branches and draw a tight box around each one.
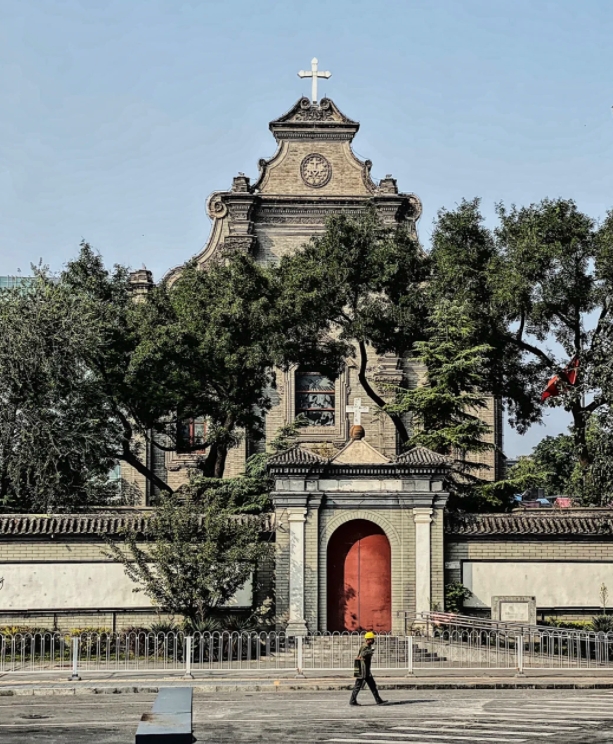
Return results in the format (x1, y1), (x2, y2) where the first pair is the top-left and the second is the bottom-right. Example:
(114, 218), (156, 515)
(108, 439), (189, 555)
(431, 199), (613, 474)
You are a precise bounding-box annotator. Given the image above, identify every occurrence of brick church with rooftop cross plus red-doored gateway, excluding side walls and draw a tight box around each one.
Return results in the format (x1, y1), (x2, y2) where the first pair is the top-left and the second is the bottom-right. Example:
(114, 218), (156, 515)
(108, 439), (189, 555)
(115, 60), (502, 634)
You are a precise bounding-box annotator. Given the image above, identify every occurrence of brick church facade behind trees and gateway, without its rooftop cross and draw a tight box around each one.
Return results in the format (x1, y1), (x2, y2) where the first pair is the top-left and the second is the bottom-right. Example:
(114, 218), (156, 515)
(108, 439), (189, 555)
(122, 97), (502, 501)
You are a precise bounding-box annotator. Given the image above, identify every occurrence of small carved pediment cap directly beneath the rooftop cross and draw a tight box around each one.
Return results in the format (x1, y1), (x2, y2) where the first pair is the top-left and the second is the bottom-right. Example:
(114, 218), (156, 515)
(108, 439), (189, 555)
(269, 98), (360, 142)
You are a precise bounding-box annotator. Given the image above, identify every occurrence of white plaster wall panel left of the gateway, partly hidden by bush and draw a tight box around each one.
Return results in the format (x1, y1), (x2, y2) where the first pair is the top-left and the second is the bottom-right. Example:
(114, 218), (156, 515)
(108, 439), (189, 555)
(0, 562), (253, 610)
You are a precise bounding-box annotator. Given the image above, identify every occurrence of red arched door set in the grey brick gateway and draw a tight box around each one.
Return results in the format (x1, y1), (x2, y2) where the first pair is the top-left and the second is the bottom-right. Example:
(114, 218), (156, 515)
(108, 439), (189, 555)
(327, 519), (392, 633)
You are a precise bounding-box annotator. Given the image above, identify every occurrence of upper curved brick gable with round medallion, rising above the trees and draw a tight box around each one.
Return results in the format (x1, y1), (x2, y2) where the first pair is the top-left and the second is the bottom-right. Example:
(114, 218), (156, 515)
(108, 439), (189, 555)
(165, 97), (421, 284)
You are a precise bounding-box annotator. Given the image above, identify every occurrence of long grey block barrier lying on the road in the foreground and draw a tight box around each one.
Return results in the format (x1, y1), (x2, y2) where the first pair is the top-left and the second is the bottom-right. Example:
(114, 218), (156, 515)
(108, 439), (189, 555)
(134, 687), (194, 744)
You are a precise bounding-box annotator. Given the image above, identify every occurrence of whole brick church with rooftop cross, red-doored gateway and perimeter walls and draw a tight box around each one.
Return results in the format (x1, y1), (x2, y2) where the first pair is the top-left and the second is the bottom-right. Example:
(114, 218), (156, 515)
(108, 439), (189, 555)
(0, 65), (613, 636)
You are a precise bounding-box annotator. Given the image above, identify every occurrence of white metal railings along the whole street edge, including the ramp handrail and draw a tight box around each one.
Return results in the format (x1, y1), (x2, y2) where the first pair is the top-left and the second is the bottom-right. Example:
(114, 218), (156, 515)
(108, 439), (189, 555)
(0, 613), (613, 679)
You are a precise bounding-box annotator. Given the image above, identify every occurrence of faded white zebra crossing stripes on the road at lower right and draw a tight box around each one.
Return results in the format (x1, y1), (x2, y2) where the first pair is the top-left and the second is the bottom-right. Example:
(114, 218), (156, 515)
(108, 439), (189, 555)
(326, 691), (613, 744)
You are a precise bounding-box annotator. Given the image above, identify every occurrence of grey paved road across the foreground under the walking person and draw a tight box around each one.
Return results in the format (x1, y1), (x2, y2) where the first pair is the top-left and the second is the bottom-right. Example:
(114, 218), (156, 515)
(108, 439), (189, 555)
(0, 690), (613, 744)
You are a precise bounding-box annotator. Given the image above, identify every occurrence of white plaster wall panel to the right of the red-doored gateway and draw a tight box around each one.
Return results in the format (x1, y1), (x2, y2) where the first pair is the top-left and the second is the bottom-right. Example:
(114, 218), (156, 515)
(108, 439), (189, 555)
(462, 561), (613, 607)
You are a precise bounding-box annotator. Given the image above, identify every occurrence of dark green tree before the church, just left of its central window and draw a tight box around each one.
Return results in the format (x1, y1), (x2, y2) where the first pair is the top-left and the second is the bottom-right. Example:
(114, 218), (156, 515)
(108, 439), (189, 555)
(145, 254), (338, 478)
